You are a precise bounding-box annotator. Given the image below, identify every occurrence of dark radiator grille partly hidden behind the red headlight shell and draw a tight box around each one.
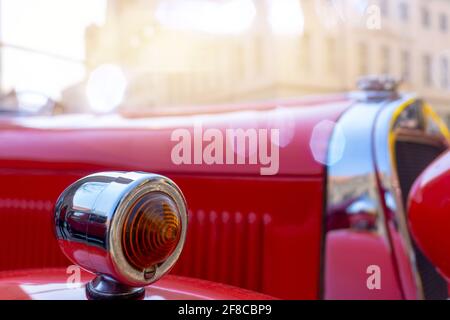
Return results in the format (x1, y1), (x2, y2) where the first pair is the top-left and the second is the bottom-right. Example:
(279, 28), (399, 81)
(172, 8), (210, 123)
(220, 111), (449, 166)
(396, 141), (448, 300)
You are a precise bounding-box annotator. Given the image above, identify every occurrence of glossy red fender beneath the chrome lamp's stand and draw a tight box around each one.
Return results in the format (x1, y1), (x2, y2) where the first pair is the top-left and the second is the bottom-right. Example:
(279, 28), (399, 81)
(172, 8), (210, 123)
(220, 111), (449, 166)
(0, 269), (273, 300)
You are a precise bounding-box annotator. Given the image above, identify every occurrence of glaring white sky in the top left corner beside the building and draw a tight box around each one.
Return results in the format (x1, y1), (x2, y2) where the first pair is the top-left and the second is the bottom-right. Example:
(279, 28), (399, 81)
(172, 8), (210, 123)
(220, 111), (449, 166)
(0, 0), (107, 100)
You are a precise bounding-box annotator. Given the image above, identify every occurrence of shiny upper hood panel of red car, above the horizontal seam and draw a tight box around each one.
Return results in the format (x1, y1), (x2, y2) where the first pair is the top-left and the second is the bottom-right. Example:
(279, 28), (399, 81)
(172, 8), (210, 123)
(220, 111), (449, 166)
(0, 96), (351, 176)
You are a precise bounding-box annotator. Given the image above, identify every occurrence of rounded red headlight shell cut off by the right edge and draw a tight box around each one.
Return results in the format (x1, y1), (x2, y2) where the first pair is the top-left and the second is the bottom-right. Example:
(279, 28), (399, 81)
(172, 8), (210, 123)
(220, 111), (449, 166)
(409, 152), (450, 280)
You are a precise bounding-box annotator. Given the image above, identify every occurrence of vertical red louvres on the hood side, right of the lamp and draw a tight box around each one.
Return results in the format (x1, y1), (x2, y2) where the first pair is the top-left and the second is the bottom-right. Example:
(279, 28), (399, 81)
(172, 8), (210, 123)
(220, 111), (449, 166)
(174, 210), (270, 291)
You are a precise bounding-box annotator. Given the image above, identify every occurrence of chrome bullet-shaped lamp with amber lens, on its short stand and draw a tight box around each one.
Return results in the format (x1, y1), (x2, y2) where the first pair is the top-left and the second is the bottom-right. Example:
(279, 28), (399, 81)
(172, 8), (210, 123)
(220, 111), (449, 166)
(54, 172), (188, 299)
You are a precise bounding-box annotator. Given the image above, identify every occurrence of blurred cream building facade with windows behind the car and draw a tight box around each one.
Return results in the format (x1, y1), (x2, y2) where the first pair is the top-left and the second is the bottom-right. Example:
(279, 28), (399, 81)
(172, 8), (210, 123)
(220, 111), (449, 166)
(63, 0), (450, 122)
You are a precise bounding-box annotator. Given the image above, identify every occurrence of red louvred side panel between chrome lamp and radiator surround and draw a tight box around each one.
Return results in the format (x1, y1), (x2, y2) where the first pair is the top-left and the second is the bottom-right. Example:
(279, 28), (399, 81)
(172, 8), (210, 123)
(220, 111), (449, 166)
(171, 177), (324, 299)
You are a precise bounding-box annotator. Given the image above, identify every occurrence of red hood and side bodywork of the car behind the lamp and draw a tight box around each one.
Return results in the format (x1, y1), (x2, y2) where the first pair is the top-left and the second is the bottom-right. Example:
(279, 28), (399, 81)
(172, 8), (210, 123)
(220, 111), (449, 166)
(0, 89), (448, 299)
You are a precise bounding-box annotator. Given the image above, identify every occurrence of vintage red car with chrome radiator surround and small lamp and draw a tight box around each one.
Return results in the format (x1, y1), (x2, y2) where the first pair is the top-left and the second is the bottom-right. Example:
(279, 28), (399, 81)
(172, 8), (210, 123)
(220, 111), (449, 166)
(0, 78), (450, 299)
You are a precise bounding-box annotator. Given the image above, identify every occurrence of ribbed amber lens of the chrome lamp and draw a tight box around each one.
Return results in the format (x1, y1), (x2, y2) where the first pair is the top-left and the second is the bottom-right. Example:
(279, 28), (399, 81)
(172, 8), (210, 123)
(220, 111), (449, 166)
(122, 192), (181, 271)
